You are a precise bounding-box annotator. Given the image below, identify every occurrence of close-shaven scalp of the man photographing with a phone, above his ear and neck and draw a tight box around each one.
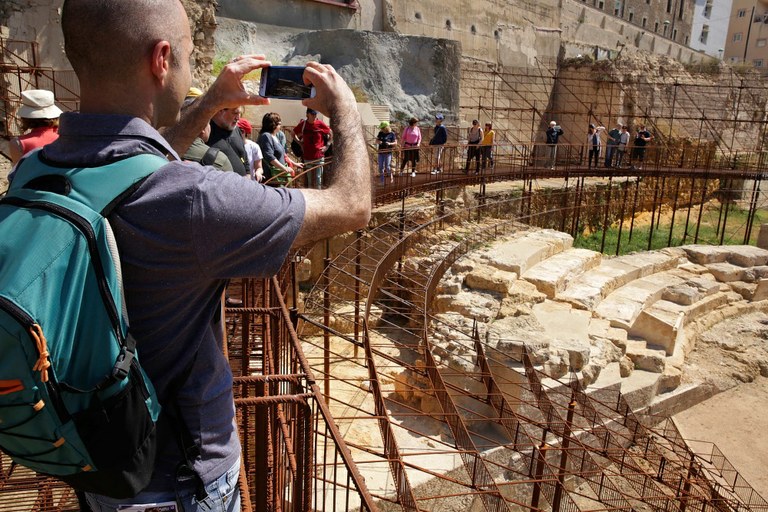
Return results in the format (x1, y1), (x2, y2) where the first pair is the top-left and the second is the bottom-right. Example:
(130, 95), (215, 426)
(61, 0), (188, 80)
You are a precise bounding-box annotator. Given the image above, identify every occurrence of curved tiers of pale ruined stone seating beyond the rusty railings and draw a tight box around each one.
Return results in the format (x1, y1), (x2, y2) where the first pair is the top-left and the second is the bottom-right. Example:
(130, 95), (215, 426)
(432, 235), (768, 420)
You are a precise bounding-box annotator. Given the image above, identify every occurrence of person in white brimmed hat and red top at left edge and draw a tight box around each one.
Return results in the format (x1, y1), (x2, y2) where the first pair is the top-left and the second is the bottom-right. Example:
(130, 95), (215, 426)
(10, 89), (61, 164)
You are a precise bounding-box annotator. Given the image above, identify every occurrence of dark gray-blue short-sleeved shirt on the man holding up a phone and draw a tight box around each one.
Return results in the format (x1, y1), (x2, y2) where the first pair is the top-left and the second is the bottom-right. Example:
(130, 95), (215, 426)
(36, 113), (305, 490)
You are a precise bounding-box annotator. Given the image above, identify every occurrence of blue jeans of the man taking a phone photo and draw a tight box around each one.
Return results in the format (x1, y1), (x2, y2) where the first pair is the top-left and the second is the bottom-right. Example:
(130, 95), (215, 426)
(85, 459), (240, 512)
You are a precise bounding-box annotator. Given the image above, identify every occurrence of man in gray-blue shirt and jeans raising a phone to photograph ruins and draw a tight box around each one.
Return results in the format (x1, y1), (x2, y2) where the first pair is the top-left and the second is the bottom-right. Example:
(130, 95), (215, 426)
(0, 0), (371, 512)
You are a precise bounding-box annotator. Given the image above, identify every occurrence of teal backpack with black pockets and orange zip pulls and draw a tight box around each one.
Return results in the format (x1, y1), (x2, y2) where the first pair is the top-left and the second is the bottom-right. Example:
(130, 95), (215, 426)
(0, 152), (168, 498)
